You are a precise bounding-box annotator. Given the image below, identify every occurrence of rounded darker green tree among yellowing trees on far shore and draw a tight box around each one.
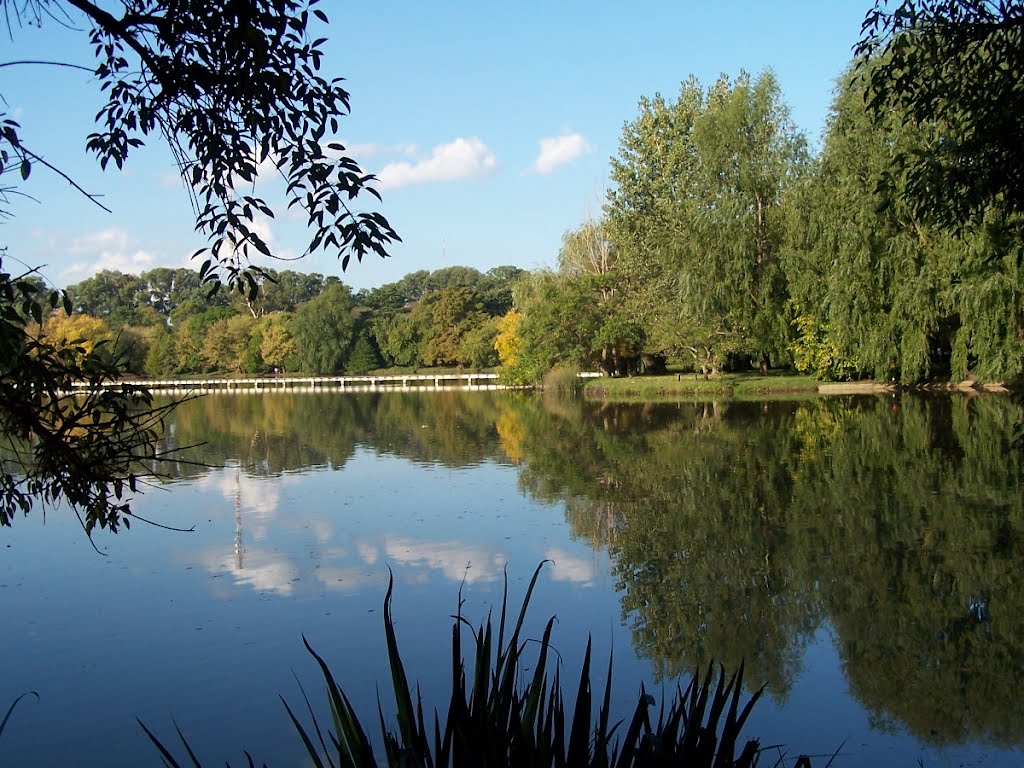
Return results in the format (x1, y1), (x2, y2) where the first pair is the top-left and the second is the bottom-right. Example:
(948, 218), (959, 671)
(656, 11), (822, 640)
(291, 284), (355, 374)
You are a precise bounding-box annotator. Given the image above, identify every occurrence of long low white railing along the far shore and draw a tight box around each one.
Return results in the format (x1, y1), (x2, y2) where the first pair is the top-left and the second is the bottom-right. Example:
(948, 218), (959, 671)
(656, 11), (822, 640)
(64, 372), (600, 393)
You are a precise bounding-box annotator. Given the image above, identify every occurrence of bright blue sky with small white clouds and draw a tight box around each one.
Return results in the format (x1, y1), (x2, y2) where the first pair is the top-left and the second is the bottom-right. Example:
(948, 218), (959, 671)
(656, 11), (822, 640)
(0, 0), (872, 290)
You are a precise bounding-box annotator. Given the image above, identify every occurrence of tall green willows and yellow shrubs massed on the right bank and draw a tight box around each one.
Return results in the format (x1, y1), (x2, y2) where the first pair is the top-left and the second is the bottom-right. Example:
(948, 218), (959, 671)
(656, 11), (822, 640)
(499, 54), (1024, 383)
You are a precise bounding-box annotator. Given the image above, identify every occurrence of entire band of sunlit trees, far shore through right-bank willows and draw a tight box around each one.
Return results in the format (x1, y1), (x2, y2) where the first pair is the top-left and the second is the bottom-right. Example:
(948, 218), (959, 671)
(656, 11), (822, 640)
(41, 55), (1024, 383)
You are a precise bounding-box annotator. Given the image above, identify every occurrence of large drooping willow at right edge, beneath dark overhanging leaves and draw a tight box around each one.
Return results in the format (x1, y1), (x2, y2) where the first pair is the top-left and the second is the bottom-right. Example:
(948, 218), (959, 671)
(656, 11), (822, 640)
(785, 64), (1024, 383)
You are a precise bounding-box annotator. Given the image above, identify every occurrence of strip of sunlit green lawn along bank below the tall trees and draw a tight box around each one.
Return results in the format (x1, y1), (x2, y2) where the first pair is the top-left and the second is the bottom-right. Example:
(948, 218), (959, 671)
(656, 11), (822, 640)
(584, 371), (819, 400)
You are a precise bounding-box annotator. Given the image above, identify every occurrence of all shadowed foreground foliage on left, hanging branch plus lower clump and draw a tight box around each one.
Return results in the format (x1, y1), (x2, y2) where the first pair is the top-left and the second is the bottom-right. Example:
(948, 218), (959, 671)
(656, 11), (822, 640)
(0, 0), (398, 531)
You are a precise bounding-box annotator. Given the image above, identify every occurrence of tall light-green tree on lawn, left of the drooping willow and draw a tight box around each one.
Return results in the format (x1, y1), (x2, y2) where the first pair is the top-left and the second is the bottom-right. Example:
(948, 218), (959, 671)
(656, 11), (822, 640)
(606, 72), (807, 368)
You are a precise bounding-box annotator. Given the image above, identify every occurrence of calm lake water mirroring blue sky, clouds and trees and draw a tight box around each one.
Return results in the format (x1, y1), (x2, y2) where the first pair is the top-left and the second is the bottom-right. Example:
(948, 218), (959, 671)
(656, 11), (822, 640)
(0, 392), (1024, 766)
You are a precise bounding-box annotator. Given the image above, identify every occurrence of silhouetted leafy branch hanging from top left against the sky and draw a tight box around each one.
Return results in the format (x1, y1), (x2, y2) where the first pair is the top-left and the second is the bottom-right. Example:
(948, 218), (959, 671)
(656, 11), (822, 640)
(0, 0), (397, 293)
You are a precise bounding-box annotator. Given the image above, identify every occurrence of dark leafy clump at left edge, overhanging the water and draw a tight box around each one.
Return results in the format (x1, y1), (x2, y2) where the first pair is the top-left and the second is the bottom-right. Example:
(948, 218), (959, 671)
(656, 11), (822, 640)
(0, 261), (180, 534)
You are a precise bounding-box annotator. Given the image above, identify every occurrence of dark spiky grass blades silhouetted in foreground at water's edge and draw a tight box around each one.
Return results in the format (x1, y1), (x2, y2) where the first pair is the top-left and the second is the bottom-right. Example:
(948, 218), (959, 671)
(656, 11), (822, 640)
(140, 563), (810, 768)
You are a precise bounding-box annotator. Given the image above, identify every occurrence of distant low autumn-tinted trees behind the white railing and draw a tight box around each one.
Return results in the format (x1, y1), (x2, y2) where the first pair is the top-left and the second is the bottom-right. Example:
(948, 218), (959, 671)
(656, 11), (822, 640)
(42, 266), (522, 377)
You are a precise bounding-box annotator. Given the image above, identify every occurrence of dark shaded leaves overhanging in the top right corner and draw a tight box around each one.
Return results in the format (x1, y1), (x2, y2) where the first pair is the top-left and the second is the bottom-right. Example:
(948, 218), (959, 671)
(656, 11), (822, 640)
(855, 0), (1024, 227)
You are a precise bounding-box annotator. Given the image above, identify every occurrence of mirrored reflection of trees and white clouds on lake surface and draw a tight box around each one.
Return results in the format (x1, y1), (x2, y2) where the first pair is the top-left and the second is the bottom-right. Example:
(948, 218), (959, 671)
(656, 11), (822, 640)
(153, 392), (1024, 745)
